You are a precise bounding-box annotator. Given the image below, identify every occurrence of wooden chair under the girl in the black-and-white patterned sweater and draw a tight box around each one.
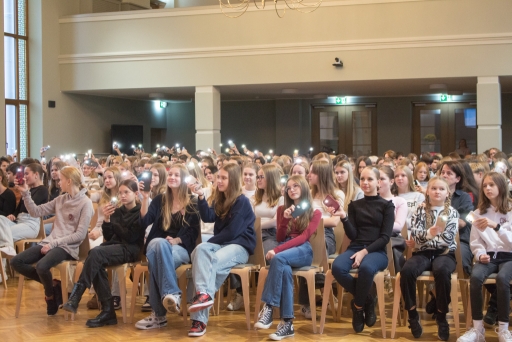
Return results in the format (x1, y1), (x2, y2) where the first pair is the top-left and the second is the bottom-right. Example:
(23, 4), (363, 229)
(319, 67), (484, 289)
(391, 228), (464, 338)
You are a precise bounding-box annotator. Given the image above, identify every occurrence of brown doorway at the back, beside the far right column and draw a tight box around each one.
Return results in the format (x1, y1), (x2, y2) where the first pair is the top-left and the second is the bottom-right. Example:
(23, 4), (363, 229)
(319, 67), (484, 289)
(412, 103), (477, 156)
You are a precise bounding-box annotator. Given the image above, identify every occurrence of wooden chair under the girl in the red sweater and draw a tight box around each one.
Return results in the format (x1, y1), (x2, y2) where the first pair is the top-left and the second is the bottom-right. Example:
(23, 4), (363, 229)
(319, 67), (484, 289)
(254, 220), (329, 334)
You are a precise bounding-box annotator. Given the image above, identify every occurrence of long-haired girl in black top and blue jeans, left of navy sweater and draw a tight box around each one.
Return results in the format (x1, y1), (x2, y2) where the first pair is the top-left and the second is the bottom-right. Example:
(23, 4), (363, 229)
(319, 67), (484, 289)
(135, 164), (200, 330)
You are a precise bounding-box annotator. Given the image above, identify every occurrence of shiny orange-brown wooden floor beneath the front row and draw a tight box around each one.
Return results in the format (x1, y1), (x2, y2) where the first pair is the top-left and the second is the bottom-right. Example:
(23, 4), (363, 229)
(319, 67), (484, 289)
(0, 278), (498, 342)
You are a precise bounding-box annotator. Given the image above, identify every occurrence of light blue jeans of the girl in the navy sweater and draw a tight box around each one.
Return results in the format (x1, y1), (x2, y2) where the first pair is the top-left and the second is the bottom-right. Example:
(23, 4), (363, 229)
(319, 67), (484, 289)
(190, 242), (249, 324)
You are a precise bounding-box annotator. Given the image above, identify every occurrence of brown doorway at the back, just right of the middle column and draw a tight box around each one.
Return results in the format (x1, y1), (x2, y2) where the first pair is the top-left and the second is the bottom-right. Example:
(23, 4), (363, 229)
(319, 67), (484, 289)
(311, 104), (377, 158)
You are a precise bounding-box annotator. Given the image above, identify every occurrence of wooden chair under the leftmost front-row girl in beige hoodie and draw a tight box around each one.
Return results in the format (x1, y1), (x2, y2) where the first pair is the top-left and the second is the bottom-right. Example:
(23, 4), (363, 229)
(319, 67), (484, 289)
(15, 234), (90, 321)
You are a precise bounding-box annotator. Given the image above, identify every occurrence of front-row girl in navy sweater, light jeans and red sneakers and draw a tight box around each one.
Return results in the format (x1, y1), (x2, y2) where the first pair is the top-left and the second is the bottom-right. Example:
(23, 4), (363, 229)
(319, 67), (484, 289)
(188, 164), (256, 336)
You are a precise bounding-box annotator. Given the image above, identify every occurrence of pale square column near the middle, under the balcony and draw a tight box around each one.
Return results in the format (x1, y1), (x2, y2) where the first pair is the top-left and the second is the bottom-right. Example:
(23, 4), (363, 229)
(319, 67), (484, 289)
(195, 86), (222, 153)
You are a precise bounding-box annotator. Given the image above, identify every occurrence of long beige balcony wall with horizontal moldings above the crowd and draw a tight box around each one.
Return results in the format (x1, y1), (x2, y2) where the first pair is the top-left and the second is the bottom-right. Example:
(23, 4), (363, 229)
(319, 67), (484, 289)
(56, 0), (512, 90)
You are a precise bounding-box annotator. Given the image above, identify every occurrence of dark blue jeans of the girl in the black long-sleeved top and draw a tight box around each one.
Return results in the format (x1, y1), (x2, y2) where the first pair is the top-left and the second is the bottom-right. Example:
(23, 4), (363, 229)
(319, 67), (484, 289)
(332, 246), (388, 307)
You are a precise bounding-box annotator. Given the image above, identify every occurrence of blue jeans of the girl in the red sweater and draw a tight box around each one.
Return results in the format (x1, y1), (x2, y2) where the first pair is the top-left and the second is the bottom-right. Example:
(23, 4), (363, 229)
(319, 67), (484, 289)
(261, 241), (313, 319)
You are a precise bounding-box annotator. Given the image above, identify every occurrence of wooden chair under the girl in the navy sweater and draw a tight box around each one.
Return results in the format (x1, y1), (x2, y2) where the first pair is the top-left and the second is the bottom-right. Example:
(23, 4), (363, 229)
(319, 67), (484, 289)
(217, 217), (266, 330)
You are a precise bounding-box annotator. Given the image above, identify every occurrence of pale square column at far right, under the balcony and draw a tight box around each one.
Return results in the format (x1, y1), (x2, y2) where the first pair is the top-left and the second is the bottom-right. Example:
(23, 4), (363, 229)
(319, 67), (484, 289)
(476, 76), (502, 153)
